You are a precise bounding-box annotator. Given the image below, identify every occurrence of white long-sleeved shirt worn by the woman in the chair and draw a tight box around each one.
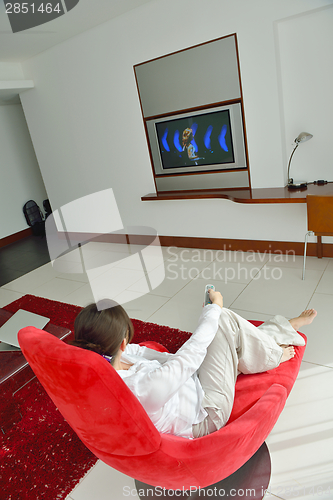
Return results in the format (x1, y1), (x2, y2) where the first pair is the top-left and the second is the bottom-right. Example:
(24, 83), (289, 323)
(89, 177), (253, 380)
(118, 304), (221, 438)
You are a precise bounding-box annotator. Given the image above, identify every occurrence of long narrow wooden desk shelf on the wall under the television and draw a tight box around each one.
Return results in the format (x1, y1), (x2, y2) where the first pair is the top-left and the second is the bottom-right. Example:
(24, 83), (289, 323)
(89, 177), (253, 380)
(141, 183), (333, 204)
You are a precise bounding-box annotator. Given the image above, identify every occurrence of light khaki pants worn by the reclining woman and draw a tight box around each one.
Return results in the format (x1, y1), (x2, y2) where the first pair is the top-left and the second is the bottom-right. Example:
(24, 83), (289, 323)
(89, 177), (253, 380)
(193, 308), (305, 437)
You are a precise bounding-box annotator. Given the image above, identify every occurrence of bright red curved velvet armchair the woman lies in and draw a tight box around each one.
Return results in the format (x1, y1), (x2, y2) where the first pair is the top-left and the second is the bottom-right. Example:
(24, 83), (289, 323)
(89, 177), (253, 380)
(18, 322), (306, 489)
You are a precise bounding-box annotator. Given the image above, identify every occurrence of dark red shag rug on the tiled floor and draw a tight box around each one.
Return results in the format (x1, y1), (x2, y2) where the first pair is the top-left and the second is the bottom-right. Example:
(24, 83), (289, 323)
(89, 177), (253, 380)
(0, 295), (190, 500)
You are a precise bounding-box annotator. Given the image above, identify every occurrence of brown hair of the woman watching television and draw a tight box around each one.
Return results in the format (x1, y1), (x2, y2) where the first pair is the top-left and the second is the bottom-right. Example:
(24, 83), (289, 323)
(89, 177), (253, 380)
(70, 301), (134, 363)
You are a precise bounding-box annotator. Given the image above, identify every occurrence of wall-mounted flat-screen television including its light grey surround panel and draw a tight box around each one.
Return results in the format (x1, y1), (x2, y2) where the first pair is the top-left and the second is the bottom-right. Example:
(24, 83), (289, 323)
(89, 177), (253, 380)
(147, 103), (247, 176)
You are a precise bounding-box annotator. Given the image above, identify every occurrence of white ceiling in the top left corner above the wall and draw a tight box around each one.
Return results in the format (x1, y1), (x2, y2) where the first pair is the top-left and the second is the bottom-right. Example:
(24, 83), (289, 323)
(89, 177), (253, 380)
(0, 0), (151, 62)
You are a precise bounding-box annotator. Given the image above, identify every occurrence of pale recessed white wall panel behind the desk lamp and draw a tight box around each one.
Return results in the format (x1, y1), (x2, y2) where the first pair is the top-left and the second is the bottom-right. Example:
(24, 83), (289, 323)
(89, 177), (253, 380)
(276, 6), (333, 186)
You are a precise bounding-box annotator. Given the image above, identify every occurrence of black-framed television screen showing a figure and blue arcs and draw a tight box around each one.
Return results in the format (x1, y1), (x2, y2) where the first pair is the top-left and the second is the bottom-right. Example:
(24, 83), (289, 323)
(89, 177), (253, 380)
(155, 109), (235, 170)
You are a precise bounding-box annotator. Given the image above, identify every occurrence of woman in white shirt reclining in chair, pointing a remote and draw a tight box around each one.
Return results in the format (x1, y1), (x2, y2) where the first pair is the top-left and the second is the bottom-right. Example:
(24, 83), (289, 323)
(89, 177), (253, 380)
(72, 290), (317, 438)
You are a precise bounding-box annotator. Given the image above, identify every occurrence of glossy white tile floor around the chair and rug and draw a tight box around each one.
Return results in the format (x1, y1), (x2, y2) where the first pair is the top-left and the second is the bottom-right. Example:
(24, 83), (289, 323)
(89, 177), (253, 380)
(0, 243), (333, 500)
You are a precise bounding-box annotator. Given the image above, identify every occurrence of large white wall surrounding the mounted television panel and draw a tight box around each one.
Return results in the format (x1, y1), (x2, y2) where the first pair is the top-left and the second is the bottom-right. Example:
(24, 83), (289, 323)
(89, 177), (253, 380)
(22, 0), (333, 241)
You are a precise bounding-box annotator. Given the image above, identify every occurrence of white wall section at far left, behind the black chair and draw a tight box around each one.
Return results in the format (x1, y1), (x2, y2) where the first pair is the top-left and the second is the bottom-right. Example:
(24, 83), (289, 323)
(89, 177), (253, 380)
(0, 104), (47, 238)
